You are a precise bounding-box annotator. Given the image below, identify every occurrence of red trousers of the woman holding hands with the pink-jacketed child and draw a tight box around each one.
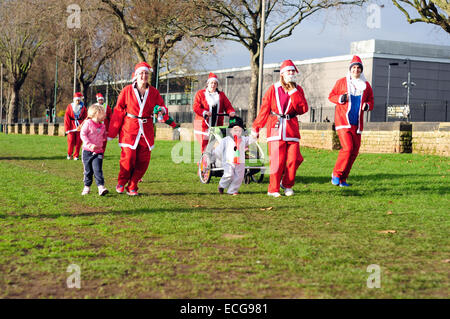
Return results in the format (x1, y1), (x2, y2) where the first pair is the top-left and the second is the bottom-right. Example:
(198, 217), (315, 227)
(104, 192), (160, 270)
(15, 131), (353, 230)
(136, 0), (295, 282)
(117, 137), (151, 191)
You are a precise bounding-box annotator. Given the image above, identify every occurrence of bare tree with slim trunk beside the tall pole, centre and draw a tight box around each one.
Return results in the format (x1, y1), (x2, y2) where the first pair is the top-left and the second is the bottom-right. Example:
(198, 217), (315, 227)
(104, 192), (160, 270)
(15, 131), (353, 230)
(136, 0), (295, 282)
(189, 0), (366, 122)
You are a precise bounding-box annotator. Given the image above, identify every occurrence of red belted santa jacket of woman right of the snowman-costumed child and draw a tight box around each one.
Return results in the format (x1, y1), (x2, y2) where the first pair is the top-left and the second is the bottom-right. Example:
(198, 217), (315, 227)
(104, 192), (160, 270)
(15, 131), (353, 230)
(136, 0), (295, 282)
(252, 82), (308, 142)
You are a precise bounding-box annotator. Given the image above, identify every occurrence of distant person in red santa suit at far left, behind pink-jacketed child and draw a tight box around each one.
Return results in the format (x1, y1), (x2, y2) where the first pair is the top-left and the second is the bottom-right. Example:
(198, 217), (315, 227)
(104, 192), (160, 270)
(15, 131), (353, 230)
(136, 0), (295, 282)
(64, 92), (87, 161)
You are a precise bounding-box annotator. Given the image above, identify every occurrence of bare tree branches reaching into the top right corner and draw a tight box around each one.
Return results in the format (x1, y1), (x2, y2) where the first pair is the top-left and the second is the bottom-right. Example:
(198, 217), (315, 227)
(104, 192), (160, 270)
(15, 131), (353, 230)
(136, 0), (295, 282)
(392, 0), (450, 33)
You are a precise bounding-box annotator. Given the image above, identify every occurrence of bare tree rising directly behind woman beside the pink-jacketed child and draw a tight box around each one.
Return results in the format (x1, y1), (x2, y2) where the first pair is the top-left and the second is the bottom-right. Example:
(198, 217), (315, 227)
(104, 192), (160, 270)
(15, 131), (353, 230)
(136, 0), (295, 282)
(101, 0), (210, 85)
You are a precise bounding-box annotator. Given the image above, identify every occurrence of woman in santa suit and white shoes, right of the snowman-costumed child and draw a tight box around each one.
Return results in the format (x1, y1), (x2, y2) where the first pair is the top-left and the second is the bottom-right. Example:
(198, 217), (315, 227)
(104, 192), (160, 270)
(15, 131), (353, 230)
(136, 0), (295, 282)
(252, 60), (308, 197)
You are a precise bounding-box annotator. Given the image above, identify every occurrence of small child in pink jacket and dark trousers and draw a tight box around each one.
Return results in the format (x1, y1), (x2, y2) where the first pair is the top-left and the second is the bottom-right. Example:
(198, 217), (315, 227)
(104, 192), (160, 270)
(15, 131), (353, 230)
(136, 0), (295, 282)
(80, 104), (108, 196)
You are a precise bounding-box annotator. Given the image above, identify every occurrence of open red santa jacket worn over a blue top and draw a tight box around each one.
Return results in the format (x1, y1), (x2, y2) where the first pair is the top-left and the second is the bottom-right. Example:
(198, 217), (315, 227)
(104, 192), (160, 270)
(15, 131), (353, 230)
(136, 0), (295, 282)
(328, 77), (374, 134)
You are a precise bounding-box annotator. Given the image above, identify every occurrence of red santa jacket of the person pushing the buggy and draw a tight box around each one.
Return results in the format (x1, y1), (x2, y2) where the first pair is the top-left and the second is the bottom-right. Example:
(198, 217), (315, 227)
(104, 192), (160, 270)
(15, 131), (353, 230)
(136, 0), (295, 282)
(193, 89), (235, 135)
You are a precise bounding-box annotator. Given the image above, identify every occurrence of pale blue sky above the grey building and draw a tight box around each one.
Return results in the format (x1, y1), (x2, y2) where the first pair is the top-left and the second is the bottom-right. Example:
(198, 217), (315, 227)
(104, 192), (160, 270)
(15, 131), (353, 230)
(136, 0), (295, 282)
(202, 0), (450, 70)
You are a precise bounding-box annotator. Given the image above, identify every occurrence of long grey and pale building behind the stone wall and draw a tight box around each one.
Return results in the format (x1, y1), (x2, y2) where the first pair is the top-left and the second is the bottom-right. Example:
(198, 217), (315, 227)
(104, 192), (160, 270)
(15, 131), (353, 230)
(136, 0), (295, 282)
(90, 40), (450, 122)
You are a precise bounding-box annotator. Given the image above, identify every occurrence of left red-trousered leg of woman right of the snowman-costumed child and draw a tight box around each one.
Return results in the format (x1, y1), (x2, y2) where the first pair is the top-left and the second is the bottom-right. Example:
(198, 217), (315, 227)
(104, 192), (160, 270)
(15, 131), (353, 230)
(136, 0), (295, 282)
(268, 141), (287, 193)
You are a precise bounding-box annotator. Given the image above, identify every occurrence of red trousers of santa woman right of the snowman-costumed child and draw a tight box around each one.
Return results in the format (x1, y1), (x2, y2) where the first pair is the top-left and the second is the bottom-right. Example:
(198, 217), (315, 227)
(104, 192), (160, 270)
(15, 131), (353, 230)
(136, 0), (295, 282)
(268, 141), (303, 193)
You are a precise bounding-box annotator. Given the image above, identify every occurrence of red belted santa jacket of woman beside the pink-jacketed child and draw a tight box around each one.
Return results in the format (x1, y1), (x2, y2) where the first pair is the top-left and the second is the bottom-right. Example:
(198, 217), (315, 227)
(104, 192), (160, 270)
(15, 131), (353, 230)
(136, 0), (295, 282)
(108, 83), (164, 150)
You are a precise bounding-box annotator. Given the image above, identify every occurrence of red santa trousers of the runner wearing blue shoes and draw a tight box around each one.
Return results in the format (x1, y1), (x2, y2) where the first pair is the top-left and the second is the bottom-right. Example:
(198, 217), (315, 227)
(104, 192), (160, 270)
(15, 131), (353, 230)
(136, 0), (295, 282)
(333, 125), (361, 182)
